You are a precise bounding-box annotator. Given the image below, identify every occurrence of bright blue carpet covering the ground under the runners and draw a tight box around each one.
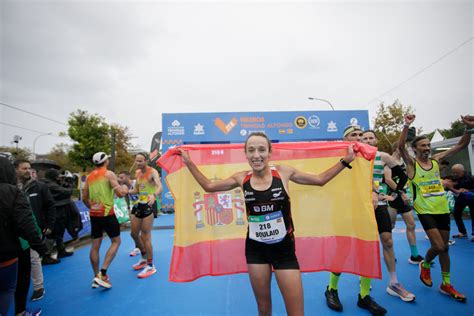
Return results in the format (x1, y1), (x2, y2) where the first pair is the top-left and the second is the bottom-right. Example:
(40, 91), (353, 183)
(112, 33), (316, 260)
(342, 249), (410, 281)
(20, 215), (474, 316)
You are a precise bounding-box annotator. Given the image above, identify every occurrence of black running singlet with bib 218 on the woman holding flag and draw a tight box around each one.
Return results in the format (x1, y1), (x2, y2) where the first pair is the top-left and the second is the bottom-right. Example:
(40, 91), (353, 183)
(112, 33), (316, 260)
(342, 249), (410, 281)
(243, 167), (294, 244)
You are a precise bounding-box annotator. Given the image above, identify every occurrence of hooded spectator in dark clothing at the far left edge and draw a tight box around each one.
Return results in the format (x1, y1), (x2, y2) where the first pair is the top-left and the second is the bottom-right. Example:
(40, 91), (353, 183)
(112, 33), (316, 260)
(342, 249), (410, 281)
(0, 157), (46, 315)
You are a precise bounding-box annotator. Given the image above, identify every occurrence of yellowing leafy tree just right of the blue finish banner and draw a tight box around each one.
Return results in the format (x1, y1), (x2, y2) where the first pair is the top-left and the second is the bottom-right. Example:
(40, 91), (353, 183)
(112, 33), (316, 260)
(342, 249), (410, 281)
(374, 99), (421, 153)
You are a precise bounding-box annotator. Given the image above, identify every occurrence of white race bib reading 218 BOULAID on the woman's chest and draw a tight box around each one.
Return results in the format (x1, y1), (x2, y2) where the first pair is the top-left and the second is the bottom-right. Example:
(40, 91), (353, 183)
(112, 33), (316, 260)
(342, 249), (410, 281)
(249, 211), (286, 244)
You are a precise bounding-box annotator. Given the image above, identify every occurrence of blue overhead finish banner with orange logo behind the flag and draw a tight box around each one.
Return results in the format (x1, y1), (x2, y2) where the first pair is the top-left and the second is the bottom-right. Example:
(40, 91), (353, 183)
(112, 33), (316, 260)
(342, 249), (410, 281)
(162, 107), (369, 210)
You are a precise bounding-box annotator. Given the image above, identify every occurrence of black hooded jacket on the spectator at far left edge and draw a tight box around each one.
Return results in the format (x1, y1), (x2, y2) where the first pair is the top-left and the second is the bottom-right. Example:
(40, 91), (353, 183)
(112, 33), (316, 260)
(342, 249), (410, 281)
(0, 157), (46, 262)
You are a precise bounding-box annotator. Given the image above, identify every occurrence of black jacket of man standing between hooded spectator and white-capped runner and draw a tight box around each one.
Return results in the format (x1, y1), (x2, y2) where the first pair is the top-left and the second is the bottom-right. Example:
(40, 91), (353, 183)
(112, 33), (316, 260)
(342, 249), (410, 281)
(23, 180), (56, 231)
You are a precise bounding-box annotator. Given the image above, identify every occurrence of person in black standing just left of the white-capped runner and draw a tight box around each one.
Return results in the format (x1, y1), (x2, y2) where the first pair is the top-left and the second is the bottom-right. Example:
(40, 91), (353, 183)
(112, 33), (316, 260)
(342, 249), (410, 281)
(42, 169), (73, 258)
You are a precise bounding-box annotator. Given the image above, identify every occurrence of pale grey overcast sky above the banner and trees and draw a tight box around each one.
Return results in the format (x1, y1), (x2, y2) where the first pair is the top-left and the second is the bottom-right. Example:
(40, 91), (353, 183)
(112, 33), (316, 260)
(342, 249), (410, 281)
(0, 0), (474, 153)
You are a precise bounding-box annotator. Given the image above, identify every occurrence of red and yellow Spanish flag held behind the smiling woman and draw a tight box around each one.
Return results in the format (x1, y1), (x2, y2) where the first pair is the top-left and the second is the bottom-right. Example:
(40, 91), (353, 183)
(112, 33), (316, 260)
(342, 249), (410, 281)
(158, 142), (381, 282)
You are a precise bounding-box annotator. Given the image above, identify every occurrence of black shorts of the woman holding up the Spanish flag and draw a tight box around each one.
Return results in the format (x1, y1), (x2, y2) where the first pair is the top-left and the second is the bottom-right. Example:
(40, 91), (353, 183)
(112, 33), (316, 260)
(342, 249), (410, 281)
(245, 234), (300, 270)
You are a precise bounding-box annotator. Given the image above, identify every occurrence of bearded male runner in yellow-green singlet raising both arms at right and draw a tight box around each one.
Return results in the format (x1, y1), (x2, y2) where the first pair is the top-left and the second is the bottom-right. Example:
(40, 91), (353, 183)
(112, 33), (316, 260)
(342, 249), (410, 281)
(398, 114), (474, 302)
